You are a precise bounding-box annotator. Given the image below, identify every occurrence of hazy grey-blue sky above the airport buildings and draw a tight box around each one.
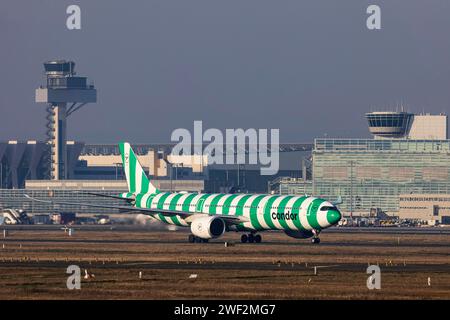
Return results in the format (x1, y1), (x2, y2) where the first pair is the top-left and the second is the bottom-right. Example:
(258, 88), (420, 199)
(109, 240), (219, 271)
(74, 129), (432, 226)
(0, 0), (450, 143)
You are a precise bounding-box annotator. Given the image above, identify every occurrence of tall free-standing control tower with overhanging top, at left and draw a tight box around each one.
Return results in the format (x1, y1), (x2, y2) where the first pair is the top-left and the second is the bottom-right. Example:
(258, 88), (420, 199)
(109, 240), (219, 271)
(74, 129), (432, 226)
(36, 60), (97, 180)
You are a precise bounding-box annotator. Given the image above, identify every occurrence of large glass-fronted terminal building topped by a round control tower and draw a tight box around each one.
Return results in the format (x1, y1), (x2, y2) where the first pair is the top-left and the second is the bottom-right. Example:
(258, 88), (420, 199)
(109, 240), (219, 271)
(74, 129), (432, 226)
(279, 112), (450, 221)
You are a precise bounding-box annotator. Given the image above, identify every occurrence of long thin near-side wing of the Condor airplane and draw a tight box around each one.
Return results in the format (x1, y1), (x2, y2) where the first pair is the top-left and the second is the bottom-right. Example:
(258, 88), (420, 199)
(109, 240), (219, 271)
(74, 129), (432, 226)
(25, 194), (249, 224)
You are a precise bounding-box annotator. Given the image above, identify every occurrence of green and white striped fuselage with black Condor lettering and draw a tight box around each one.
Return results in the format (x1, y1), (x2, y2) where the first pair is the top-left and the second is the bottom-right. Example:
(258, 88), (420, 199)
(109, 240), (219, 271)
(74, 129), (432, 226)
(130, 192), (340, 232)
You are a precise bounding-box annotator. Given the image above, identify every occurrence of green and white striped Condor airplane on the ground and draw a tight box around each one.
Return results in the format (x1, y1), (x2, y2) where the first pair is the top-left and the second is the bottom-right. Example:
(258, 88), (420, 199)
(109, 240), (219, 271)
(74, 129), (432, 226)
(25, 142), (342, 244)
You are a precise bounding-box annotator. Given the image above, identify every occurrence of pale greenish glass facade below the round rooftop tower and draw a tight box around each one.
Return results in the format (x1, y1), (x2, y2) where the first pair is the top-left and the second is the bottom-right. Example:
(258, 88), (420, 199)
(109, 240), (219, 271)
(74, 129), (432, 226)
(313, 139), (450, 214)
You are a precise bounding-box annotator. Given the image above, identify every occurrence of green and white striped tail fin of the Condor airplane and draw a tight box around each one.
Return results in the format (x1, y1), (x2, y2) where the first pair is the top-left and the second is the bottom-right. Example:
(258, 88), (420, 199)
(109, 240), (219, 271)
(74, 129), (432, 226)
(119, 142), (159, 193)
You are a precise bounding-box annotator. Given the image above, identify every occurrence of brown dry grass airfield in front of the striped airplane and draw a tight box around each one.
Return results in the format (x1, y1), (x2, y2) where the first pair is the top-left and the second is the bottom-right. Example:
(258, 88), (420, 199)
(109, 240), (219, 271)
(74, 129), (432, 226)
(0, 229), (450, 299)
